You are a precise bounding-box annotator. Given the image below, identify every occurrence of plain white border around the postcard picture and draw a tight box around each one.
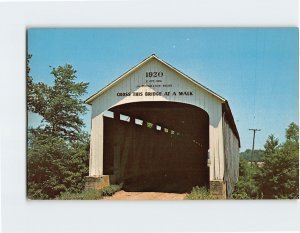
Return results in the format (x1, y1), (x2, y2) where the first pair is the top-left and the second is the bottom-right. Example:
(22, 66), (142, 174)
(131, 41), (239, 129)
(0, 0), (300, 233)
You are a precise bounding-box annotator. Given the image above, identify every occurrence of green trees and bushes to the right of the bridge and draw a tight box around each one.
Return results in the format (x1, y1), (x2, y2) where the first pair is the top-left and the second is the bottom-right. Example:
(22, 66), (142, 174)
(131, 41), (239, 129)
(236, 123), (299, 199)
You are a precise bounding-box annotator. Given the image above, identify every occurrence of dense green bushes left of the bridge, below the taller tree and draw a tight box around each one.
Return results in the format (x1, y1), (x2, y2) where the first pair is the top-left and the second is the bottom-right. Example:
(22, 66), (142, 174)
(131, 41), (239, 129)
(27, 130), (89, 199)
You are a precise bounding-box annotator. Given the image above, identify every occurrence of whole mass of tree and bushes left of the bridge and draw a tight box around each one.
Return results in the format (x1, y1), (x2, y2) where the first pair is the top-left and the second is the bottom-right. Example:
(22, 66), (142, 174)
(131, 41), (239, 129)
(26, 55), (89, 199)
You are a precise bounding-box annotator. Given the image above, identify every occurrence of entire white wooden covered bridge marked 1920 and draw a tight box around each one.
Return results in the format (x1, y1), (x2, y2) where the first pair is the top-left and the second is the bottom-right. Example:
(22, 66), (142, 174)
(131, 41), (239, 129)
(86, 54), (240, 197)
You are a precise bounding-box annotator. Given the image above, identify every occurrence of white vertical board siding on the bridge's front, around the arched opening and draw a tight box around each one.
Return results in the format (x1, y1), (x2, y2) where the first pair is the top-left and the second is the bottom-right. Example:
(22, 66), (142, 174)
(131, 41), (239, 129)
(90, 59), (224, 180)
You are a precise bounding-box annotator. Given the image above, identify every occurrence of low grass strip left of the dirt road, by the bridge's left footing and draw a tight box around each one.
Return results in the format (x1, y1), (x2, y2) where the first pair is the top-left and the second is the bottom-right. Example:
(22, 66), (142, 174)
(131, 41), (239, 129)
(57, 184), (122, 200)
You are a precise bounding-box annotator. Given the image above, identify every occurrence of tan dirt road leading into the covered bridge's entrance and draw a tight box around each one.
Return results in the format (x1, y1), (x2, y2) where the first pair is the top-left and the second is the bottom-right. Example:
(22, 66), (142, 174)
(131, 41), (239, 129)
(104, 190), (186, 200)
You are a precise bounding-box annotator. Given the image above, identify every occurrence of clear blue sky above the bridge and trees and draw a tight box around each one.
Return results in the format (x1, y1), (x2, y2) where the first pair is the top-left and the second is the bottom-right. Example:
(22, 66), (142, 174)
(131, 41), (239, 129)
(27, 28), (299, 151)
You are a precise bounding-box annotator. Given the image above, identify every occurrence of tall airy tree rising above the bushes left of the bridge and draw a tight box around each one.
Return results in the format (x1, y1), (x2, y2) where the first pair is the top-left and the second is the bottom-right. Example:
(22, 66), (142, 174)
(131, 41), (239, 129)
(27, 56), (88, 140)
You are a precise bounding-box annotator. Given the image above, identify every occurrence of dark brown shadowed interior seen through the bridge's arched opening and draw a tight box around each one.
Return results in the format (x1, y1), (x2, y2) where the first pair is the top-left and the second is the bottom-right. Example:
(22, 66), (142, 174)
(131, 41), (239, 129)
(104, 102), (209, 193)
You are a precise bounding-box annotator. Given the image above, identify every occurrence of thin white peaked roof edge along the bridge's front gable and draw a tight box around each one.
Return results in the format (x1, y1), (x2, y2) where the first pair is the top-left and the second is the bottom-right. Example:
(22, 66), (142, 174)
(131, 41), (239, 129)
(84, 54), (226, 104)
